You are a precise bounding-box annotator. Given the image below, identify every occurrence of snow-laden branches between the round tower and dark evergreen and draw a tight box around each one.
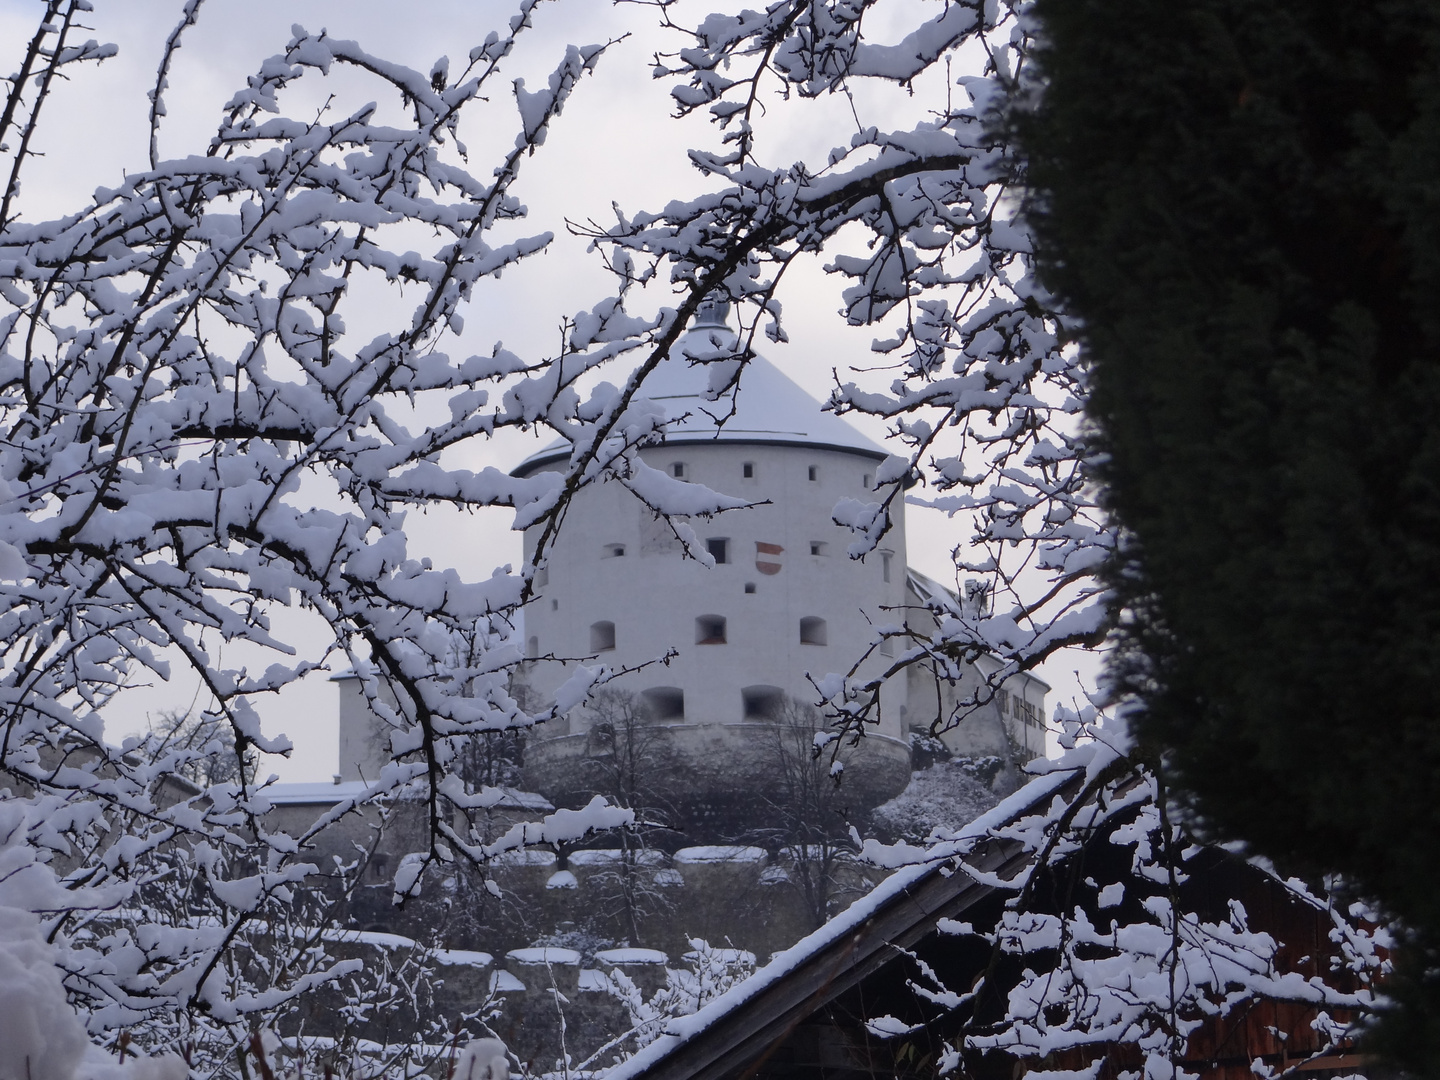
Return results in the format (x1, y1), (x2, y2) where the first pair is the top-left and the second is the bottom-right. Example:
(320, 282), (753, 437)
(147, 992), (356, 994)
(584, 0), (1115, 734)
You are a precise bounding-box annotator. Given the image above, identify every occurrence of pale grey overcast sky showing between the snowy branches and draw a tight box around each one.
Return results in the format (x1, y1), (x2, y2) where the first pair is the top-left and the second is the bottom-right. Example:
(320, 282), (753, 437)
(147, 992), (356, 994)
(0, 0), (1074, 779)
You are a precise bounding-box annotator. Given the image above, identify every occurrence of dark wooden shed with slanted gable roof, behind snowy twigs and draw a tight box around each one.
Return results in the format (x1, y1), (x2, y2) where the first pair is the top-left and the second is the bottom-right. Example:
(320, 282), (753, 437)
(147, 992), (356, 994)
(605, 742), (1365, 1080)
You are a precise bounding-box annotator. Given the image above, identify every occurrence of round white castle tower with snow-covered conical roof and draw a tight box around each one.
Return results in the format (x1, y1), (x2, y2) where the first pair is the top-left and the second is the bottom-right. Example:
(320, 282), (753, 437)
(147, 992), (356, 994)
(514, 304), (910, 837)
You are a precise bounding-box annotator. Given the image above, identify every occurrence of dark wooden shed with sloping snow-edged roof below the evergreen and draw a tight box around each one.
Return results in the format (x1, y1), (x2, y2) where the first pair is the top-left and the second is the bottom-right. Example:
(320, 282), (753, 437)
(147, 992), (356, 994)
(605, 759), (1362, 1080)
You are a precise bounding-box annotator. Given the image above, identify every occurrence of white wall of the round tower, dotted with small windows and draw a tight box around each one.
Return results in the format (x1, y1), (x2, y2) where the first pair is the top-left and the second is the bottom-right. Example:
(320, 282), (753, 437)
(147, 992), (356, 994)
(512, 441), (906, 737)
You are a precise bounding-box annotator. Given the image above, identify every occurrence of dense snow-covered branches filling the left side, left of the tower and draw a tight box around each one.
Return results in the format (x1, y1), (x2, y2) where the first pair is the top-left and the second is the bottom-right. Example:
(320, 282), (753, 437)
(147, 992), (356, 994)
(0, 0), (642, 1068)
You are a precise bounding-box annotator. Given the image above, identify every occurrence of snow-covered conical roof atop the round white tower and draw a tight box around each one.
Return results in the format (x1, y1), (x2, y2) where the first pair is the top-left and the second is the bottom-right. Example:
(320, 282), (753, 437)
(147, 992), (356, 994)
(514, 312), (890, 475)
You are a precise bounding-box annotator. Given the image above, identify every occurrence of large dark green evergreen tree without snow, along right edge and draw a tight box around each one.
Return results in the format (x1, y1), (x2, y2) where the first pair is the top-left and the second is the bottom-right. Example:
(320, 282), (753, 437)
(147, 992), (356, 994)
(1011, 0), (1440, 1071)
